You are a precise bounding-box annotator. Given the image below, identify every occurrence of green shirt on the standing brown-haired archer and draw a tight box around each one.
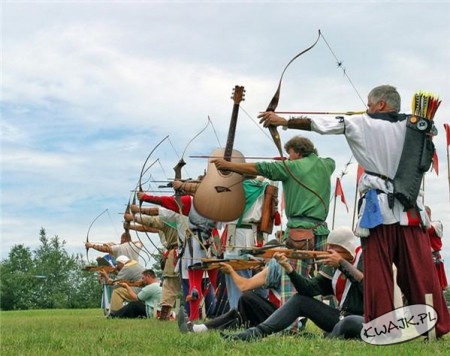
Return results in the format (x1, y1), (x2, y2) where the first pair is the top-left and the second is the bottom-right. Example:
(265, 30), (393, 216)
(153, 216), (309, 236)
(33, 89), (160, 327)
(256, 153), (336, 233)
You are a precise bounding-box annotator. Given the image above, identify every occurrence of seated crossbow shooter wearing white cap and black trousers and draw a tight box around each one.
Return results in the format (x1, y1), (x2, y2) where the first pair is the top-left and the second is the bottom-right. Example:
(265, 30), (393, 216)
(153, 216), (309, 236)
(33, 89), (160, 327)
(223, 227), (364, 341)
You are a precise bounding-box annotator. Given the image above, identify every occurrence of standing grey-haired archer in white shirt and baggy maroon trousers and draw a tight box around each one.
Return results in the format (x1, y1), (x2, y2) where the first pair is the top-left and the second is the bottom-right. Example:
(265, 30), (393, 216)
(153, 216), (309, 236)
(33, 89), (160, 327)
(259, 85), (450, 338)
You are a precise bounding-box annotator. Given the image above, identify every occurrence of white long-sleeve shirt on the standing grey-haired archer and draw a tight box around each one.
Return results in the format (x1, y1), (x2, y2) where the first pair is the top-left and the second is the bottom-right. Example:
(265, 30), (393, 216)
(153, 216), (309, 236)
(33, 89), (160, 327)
(311, 114), (429, 236)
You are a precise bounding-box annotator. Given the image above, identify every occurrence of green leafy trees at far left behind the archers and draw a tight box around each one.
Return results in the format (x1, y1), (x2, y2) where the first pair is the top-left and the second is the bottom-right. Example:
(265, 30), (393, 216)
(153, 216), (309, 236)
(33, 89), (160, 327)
(0, 228), (102, 310)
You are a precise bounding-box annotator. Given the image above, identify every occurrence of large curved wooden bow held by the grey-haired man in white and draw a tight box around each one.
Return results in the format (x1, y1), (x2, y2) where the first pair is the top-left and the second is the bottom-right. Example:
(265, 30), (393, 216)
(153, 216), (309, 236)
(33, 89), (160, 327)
(266, 30), (328, 213)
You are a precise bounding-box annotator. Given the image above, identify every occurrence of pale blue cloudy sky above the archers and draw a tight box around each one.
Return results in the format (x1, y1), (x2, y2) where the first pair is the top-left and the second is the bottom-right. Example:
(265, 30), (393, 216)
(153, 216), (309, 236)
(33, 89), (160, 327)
(1, 1), (450, 273)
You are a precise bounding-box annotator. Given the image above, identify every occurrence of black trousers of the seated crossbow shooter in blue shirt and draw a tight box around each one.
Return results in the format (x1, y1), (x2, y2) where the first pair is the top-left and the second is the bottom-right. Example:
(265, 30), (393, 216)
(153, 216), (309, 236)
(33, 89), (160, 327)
(205, 291), (277, 329)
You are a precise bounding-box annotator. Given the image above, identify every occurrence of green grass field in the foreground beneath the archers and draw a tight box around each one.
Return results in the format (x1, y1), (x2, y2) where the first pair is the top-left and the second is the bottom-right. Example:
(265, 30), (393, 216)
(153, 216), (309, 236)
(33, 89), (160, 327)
(0, 309), (450, 356)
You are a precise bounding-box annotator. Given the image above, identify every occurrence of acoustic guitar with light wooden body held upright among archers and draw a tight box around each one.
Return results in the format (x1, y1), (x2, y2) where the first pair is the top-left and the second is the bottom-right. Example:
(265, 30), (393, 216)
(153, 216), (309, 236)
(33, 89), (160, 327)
(193, 85), (245, 222)
